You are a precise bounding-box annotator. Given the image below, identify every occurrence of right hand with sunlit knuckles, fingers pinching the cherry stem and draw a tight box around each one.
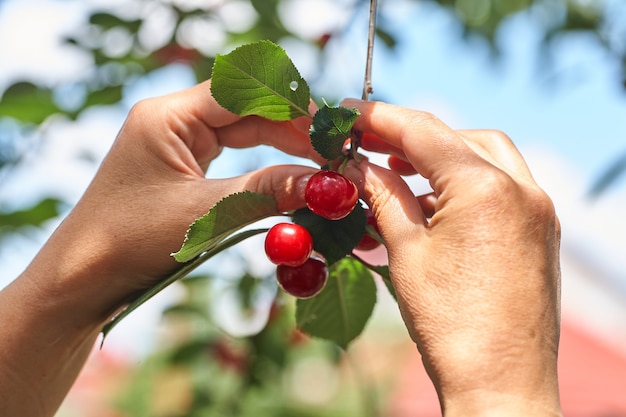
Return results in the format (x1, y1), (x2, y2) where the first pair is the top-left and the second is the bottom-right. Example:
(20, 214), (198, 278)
(343, 100), (560, 416)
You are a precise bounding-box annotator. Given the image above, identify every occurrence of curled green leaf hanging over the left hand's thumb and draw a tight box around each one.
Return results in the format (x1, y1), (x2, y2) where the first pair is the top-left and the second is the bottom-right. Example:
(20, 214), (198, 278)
(172, 191), (278, 262)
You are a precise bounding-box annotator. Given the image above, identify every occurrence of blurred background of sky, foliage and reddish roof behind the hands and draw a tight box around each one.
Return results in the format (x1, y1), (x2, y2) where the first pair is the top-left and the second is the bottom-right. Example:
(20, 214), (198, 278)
(0, 0), (626, 417)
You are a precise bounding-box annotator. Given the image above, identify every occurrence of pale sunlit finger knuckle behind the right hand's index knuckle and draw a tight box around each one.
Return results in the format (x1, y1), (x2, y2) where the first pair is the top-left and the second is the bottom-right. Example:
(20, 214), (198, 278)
(459, 130), (532, 181)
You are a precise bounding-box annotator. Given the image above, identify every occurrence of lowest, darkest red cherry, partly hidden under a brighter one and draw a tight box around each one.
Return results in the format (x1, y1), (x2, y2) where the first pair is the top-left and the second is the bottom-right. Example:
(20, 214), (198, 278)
(276, 257), (328, 298)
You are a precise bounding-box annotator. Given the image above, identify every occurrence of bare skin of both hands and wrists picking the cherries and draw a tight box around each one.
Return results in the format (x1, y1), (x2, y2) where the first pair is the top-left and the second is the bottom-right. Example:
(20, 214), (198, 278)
(0, 82), (560, 417)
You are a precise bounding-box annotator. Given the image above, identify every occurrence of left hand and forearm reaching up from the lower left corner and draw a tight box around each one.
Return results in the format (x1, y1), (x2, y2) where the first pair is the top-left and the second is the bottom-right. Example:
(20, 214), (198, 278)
(0, 82), (324, 417)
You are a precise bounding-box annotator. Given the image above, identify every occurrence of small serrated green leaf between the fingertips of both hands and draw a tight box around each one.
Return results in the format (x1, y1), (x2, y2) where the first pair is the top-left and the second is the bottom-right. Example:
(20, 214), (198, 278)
(309, 106), (359, 161)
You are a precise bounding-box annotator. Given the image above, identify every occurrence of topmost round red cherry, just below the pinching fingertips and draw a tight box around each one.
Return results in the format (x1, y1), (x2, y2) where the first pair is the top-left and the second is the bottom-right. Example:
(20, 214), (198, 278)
(304, 170), (359, 220)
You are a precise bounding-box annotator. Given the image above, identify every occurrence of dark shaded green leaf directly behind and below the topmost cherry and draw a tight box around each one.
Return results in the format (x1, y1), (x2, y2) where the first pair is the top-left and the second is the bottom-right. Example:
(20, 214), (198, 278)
(293, 204), (366, 265)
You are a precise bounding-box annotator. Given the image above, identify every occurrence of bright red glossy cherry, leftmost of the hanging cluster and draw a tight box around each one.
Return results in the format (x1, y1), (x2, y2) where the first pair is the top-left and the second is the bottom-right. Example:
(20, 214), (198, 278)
(265, 223), (313, 266)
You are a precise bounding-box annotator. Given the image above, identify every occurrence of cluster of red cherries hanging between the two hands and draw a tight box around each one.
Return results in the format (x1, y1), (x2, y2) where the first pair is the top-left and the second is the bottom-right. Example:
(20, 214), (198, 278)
(265, 170), (380, 298)
